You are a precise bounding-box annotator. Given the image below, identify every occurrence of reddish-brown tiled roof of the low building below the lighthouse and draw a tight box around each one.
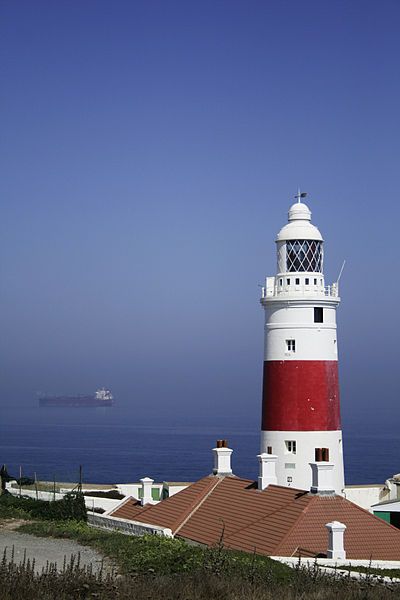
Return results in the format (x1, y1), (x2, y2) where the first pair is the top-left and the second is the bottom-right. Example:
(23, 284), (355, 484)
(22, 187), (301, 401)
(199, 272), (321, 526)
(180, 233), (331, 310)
(112, 476), (400, 560)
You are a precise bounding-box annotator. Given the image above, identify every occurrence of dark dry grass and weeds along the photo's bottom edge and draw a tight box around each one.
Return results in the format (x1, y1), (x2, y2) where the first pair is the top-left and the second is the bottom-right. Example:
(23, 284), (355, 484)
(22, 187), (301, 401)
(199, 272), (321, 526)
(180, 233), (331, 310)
(0, 540), (399, 600)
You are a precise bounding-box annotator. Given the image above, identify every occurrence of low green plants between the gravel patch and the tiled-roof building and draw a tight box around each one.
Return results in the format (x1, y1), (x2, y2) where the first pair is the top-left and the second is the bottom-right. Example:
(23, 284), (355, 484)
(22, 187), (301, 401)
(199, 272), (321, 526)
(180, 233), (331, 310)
(19, 521), (293, 580)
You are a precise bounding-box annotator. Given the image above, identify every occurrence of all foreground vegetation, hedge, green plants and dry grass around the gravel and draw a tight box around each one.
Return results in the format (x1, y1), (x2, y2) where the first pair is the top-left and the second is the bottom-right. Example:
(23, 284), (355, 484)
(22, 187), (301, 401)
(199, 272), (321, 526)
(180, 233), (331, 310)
(0, 495), (400, 600)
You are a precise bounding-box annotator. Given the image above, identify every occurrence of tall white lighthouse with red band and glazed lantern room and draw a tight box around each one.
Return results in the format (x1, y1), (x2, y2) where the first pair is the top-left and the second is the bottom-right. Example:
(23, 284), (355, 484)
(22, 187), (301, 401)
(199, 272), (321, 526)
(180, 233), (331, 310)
(261, 192), (344, 494)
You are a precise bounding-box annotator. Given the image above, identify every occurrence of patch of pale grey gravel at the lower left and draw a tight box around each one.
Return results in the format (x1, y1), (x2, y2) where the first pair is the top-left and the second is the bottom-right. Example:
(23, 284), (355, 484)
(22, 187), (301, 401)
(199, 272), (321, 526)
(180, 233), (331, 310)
(0, 520), (112, 573)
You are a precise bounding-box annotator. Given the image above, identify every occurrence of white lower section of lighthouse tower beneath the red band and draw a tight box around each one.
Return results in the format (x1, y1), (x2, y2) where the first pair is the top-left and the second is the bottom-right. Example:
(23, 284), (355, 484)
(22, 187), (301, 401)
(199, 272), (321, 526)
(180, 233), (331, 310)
(261, 431), (344, 494)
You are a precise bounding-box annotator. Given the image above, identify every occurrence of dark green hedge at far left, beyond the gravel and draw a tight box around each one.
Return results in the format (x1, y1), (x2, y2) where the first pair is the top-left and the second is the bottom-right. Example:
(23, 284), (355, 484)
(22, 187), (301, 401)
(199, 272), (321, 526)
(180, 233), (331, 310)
(0, 492), (87, 521)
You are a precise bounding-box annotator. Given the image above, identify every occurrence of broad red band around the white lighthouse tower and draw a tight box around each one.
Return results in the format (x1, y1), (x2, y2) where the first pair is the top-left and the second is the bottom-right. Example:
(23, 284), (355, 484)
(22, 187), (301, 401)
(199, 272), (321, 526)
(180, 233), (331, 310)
(262, 360), (340, 431)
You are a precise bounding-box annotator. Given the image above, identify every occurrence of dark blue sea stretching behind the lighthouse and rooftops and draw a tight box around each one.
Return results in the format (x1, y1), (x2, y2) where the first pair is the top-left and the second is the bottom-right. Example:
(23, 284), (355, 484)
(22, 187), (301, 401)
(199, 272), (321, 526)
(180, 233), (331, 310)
(0, 407), (400, 485)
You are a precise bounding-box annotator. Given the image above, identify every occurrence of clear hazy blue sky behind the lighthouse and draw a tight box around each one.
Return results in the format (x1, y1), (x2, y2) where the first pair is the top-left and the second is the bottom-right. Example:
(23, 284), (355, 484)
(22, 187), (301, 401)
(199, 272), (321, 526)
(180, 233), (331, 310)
(0, 0), (400, 432)
